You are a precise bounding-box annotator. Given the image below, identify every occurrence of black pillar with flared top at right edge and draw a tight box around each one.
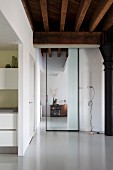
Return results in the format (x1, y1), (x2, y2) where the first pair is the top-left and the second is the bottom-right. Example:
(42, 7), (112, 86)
(100, 31), (113, 136)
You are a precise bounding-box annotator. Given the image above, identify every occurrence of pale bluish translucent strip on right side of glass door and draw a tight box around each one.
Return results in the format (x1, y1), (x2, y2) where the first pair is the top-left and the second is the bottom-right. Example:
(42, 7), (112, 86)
(67, 49), (78, 130)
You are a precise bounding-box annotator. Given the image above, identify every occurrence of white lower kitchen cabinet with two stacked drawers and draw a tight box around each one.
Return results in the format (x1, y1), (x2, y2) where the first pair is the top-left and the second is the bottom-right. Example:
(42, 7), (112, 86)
(0, 112), (18, 147)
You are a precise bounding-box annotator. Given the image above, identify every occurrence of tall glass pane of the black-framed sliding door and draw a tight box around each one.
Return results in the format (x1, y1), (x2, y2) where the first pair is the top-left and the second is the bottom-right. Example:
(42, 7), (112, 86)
(46, 49), (78, 131)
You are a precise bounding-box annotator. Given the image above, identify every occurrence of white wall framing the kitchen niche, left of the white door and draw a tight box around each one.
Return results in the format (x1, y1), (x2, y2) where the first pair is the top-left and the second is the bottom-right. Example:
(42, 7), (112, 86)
(0, 0), (40, 156)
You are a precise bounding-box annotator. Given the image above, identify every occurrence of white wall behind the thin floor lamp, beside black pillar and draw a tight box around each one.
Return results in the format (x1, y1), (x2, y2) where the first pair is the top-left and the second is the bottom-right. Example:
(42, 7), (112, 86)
(79, 49), (104, 131)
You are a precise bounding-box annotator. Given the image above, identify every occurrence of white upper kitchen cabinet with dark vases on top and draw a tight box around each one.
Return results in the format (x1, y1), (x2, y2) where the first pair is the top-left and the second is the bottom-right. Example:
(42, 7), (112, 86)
(0, 68), (18, 89)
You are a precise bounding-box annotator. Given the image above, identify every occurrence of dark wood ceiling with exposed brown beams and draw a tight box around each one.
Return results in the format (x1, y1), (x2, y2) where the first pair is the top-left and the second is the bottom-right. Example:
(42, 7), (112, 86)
(22, 0), (113, 55)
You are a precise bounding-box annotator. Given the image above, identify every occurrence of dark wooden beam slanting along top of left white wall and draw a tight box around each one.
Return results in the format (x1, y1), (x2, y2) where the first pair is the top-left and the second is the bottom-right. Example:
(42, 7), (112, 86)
(21, 0), (34, 31)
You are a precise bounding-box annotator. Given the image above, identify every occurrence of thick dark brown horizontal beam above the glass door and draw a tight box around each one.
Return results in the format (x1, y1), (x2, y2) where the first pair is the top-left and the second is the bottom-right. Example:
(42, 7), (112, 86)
(33, 32), (102, 45)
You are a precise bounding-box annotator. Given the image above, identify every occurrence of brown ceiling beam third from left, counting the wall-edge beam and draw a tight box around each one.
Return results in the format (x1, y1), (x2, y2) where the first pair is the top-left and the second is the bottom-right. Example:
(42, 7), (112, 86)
(60, 0), (68, 31)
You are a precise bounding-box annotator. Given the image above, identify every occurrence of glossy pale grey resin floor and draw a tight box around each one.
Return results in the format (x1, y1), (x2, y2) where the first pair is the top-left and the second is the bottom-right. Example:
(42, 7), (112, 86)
(0, 128), (113, 170)
